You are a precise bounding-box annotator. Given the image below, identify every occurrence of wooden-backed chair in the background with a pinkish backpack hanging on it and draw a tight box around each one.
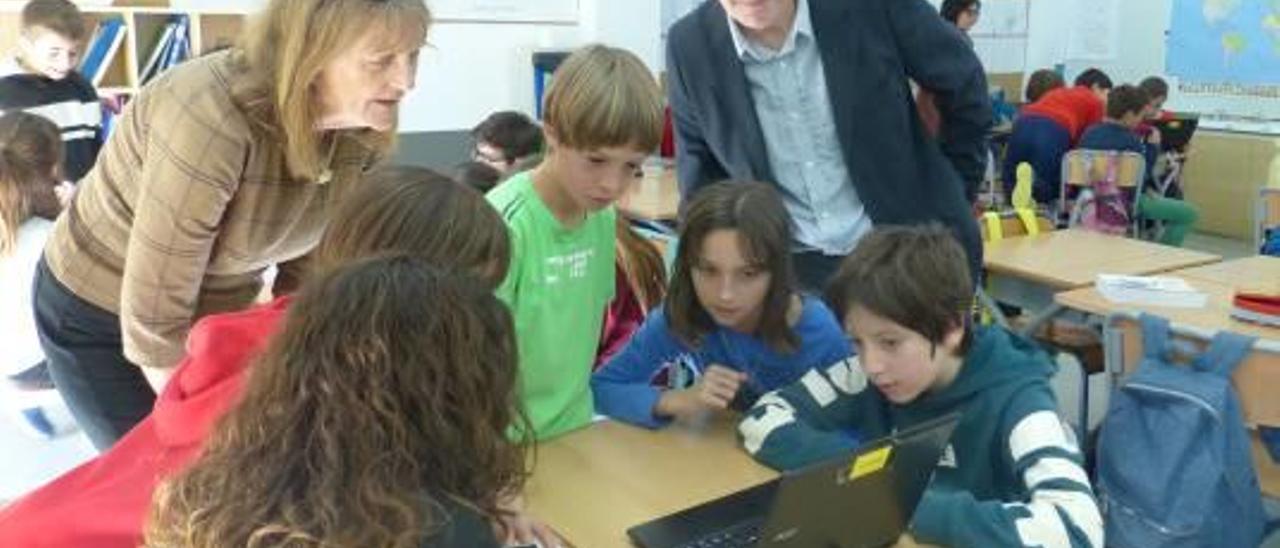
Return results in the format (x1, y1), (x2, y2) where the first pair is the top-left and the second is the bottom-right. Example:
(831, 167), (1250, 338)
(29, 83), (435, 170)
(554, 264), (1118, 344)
(1056, 149), (1147, 236)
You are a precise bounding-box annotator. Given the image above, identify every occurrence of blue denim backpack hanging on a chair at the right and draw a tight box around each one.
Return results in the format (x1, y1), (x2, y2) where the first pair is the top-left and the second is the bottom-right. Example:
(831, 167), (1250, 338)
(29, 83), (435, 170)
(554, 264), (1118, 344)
(1097, 314), (1266, 548)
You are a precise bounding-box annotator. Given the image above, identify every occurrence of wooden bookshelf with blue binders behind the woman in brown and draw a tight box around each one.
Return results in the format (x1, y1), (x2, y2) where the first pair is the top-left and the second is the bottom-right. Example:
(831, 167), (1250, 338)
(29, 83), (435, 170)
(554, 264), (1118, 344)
(0, 0), (247, 96)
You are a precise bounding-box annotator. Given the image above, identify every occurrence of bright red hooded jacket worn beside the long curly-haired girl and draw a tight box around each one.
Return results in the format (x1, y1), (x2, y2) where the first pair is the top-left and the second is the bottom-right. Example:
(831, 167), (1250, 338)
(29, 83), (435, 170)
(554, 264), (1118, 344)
(0, 297), (289, 548)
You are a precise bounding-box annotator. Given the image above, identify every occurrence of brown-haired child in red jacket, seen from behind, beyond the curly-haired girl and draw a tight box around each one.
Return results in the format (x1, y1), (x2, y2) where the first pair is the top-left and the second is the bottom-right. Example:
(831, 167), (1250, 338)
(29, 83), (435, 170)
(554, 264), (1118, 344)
(0, 166), (558, 548)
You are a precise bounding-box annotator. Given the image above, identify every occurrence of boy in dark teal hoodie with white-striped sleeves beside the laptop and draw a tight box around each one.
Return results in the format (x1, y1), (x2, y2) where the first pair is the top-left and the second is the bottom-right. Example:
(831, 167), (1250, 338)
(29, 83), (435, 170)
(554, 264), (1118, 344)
(739, 225), (1103, 547)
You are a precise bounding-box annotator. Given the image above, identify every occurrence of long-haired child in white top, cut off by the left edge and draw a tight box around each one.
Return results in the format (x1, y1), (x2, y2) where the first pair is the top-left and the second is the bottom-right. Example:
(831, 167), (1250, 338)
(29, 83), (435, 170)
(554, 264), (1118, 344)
(0, 111), (69, 438)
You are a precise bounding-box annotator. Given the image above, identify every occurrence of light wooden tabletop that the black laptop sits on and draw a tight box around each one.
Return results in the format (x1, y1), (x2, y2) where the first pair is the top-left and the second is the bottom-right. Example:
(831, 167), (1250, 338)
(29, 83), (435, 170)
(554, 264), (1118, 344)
(525, 417), (777, 548)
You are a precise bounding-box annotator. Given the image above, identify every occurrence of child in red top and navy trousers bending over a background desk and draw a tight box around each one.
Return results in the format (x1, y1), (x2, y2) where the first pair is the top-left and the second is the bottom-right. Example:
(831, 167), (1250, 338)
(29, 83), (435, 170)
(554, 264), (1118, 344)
(1001, 69), (1112, 204)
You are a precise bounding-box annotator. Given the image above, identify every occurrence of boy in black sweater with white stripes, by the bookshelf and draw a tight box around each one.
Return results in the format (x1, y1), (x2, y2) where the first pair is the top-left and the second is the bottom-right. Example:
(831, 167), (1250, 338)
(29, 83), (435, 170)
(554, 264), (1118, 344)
(0, 0), (104, 182)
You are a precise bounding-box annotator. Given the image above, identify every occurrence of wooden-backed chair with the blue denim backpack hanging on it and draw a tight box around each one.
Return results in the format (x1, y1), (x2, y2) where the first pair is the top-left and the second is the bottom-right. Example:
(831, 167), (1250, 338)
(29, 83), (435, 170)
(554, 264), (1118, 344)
(1100, 312), (1280, 498)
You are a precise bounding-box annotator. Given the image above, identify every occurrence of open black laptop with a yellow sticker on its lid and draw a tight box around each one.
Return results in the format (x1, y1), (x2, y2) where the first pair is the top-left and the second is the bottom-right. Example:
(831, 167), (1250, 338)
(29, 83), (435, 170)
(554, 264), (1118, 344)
(627, 414), (959, 548)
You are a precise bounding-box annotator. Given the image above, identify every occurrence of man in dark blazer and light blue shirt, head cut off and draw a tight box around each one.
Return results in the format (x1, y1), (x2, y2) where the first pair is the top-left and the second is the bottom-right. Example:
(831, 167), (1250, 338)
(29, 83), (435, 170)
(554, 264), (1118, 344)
(667, 0), (991, 289)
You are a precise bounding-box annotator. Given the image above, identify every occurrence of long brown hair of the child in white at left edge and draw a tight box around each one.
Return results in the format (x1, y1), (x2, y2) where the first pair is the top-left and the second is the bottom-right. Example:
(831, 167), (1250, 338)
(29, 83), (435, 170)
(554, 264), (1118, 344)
(0, 111), (63, 257)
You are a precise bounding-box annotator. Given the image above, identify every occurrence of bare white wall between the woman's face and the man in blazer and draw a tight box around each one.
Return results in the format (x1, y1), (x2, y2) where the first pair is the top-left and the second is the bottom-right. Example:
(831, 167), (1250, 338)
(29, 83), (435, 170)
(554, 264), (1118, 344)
(173, 0), (662, 132)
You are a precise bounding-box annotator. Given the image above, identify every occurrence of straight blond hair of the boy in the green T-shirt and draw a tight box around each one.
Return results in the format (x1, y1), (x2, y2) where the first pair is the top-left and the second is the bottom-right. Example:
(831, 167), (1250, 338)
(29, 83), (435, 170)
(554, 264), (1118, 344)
(543, 44), (663, 151)
